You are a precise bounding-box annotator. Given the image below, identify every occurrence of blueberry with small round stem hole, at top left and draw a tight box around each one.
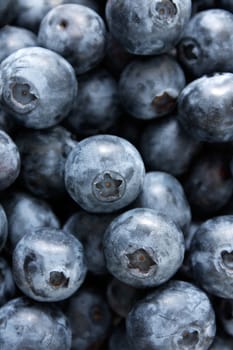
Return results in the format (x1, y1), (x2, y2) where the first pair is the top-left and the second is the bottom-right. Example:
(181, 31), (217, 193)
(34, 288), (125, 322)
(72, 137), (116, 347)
(38, 4), (107, 74)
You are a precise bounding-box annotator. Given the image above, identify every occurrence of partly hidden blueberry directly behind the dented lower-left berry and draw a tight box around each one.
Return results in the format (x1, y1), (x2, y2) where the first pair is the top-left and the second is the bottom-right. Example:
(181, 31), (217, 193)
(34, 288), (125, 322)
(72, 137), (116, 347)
(3, 192), (60, 248)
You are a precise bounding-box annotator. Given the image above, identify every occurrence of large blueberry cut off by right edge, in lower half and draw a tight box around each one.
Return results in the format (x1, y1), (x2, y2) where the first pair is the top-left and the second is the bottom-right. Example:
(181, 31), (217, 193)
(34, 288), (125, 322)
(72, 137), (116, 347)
(190, 215), (233, 299)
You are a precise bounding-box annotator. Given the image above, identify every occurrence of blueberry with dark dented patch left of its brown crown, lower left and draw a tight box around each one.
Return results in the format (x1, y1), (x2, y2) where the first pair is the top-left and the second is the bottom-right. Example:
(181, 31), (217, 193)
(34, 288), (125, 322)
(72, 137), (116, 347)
(13, 228), (86, 302)
